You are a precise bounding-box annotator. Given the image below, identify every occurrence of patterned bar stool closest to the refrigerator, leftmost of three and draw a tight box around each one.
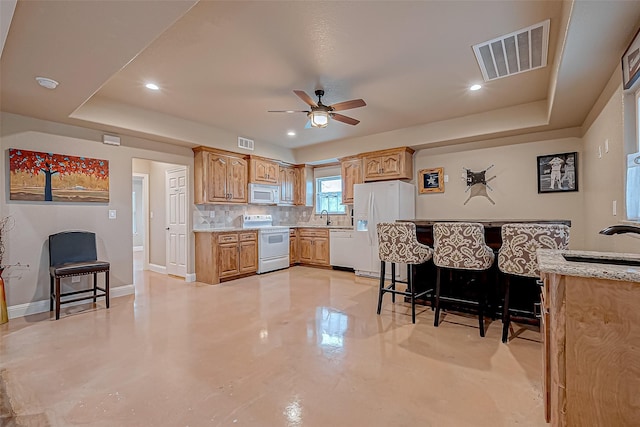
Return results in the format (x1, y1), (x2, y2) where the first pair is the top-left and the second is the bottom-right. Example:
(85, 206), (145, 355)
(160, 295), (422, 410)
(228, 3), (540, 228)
(376, 222), (433, 323)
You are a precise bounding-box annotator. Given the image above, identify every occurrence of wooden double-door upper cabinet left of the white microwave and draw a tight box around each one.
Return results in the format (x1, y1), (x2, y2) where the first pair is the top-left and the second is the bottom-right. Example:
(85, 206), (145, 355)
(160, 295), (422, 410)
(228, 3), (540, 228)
(193, 147), (247, 204)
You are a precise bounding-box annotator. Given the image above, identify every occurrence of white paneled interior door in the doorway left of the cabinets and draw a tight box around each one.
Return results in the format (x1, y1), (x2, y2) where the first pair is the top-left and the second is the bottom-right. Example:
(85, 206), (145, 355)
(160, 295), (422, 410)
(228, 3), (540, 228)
(166, 168), (189, 277)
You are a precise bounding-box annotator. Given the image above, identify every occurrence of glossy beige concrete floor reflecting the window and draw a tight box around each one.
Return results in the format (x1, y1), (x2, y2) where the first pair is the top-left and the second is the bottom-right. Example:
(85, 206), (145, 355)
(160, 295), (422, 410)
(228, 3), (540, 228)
(0, 267), (546, 427)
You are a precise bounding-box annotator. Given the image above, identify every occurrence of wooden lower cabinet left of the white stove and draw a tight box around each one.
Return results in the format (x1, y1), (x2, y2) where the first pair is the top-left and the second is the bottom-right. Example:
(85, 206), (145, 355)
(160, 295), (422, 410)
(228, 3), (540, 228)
(195, 231), (258, 284)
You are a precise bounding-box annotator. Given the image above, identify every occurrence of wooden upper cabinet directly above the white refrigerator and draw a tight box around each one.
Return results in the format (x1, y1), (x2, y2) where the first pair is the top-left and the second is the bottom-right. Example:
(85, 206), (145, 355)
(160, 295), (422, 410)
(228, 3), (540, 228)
(362, 147), (414, 182)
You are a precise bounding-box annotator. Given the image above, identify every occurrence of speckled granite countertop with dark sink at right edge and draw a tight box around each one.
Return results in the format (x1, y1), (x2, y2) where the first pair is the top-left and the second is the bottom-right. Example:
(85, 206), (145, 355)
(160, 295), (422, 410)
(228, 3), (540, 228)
(537, 249), (640, 283)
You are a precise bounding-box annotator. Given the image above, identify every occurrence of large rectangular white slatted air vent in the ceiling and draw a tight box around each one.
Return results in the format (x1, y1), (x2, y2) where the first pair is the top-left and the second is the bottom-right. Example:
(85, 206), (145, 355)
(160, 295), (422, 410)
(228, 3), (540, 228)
(473, 19), (549, 81)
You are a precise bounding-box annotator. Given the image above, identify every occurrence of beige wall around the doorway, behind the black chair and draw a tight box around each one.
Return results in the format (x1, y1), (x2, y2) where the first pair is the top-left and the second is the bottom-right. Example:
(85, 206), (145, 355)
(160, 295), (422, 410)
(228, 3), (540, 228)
(0, 113), (193, 311)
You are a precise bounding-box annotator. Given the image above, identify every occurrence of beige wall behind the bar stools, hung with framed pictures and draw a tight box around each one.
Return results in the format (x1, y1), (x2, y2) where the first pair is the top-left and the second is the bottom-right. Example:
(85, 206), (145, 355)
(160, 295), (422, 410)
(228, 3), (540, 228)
(414, 138), (584, 248)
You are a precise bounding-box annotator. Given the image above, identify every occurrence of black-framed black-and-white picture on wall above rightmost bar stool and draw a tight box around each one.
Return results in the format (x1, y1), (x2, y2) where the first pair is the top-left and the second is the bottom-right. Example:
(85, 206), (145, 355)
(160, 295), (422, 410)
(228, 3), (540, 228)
(537, 153), (578, 193)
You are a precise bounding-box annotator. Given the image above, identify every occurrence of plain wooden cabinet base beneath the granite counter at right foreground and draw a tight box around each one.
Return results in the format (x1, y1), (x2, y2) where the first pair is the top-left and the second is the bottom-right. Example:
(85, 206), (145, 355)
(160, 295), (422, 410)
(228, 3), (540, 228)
(542, 273), (640, 426)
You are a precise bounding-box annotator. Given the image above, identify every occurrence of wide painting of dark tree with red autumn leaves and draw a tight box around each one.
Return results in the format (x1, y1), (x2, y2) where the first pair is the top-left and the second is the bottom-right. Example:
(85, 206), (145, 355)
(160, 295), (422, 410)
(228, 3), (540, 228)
(9, 148), (109, 203)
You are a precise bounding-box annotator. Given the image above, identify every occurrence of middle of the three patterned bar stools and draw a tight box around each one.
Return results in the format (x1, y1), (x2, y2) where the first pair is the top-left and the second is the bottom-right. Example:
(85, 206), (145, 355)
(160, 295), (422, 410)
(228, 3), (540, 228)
(433, 222), (495, 337)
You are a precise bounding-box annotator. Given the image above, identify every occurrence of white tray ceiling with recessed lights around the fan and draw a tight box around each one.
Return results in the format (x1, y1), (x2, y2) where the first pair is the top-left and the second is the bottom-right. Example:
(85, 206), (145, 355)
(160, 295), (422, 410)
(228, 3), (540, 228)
(0, 0), (640, 160)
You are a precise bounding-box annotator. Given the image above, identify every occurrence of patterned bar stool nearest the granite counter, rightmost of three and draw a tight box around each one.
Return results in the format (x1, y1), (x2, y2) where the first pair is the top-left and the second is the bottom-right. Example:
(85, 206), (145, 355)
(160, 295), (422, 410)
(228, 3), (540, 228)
(498, 223), (569, 343)
